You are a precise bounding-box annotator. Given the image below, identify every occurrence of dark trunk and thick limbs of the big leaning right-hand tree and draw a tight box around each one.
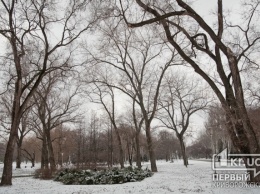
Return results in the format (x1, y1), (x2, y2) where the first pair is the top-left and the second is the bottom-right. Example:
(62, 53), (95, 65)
(124, 0), (260, 182)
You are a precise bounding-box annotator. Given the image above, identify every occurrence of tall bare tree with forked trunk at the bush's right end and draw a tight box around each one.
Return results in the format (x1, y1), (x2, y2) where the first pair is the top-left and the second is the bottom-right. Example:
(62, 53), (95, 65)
(85, 19), (179, 172)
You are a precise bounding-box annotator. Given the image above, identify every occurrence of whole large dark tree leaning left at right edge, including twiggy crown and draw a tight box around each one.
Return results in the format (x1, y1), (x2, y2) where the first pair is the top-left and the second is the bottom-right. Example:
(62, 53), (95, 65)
(120, 0), (260, 182)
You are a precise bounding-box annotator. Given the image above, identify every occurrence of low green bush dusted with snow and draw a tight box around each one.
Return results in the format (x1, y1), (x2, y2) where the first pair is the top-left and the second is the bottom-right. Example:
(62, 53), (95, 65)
(54, 167), (153, 185)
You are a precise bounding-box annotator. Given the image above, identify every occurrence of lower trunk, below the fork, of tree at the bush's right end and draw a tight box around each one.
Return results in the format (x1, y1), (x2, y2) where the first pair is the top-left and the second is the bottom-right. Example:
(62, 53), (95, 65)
(145, 126), (157, 172)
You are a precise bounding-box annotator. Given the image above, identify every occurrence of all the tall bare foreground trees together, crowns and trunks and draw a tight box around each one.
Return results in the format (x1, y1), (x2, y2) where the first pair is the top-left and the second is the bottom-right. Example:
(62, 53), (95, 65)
(0, 0), (260, 185)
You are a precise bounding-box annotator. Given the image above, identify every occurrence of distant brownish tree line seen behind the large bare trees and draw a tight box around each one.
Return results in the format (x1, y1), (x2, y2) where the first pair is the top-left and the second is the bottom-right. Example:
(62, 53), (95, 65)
(4, 106), (259, 172)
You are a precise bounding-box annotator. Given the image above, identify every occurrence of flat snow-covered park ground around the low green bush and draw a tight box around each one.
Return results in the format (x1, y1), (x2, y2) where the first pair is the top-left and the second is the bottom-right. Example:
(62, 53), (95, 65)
(0, 161), (260, 194)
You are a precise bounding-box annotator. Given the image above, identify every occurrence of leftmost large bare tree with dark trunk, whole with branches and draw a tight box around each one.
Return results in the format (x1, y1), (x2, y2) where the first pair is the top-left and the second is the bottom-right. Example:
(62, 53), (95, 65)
(0, 0), (100, 185)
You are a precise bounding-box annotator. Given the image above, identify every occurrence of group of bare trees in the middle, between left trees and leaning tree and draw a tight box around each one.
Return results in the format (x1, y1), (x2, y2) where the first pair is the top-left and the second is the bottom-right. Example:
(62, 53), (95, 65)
(83, 15), (211, 172)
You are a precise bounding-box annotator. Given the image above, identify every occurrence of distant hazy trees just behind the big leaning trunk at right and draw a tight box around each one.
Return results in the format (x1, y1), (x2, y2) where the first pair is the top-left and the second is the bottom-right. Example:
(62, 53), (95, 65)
(187, 105), (260, 159)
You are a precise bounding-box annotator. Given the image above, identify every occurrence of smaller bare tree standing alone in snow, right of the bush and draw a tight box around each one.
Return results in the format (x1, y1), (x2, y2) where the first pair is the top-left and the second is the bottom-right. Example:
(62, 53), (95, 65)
(158, 74), (209, 167)
